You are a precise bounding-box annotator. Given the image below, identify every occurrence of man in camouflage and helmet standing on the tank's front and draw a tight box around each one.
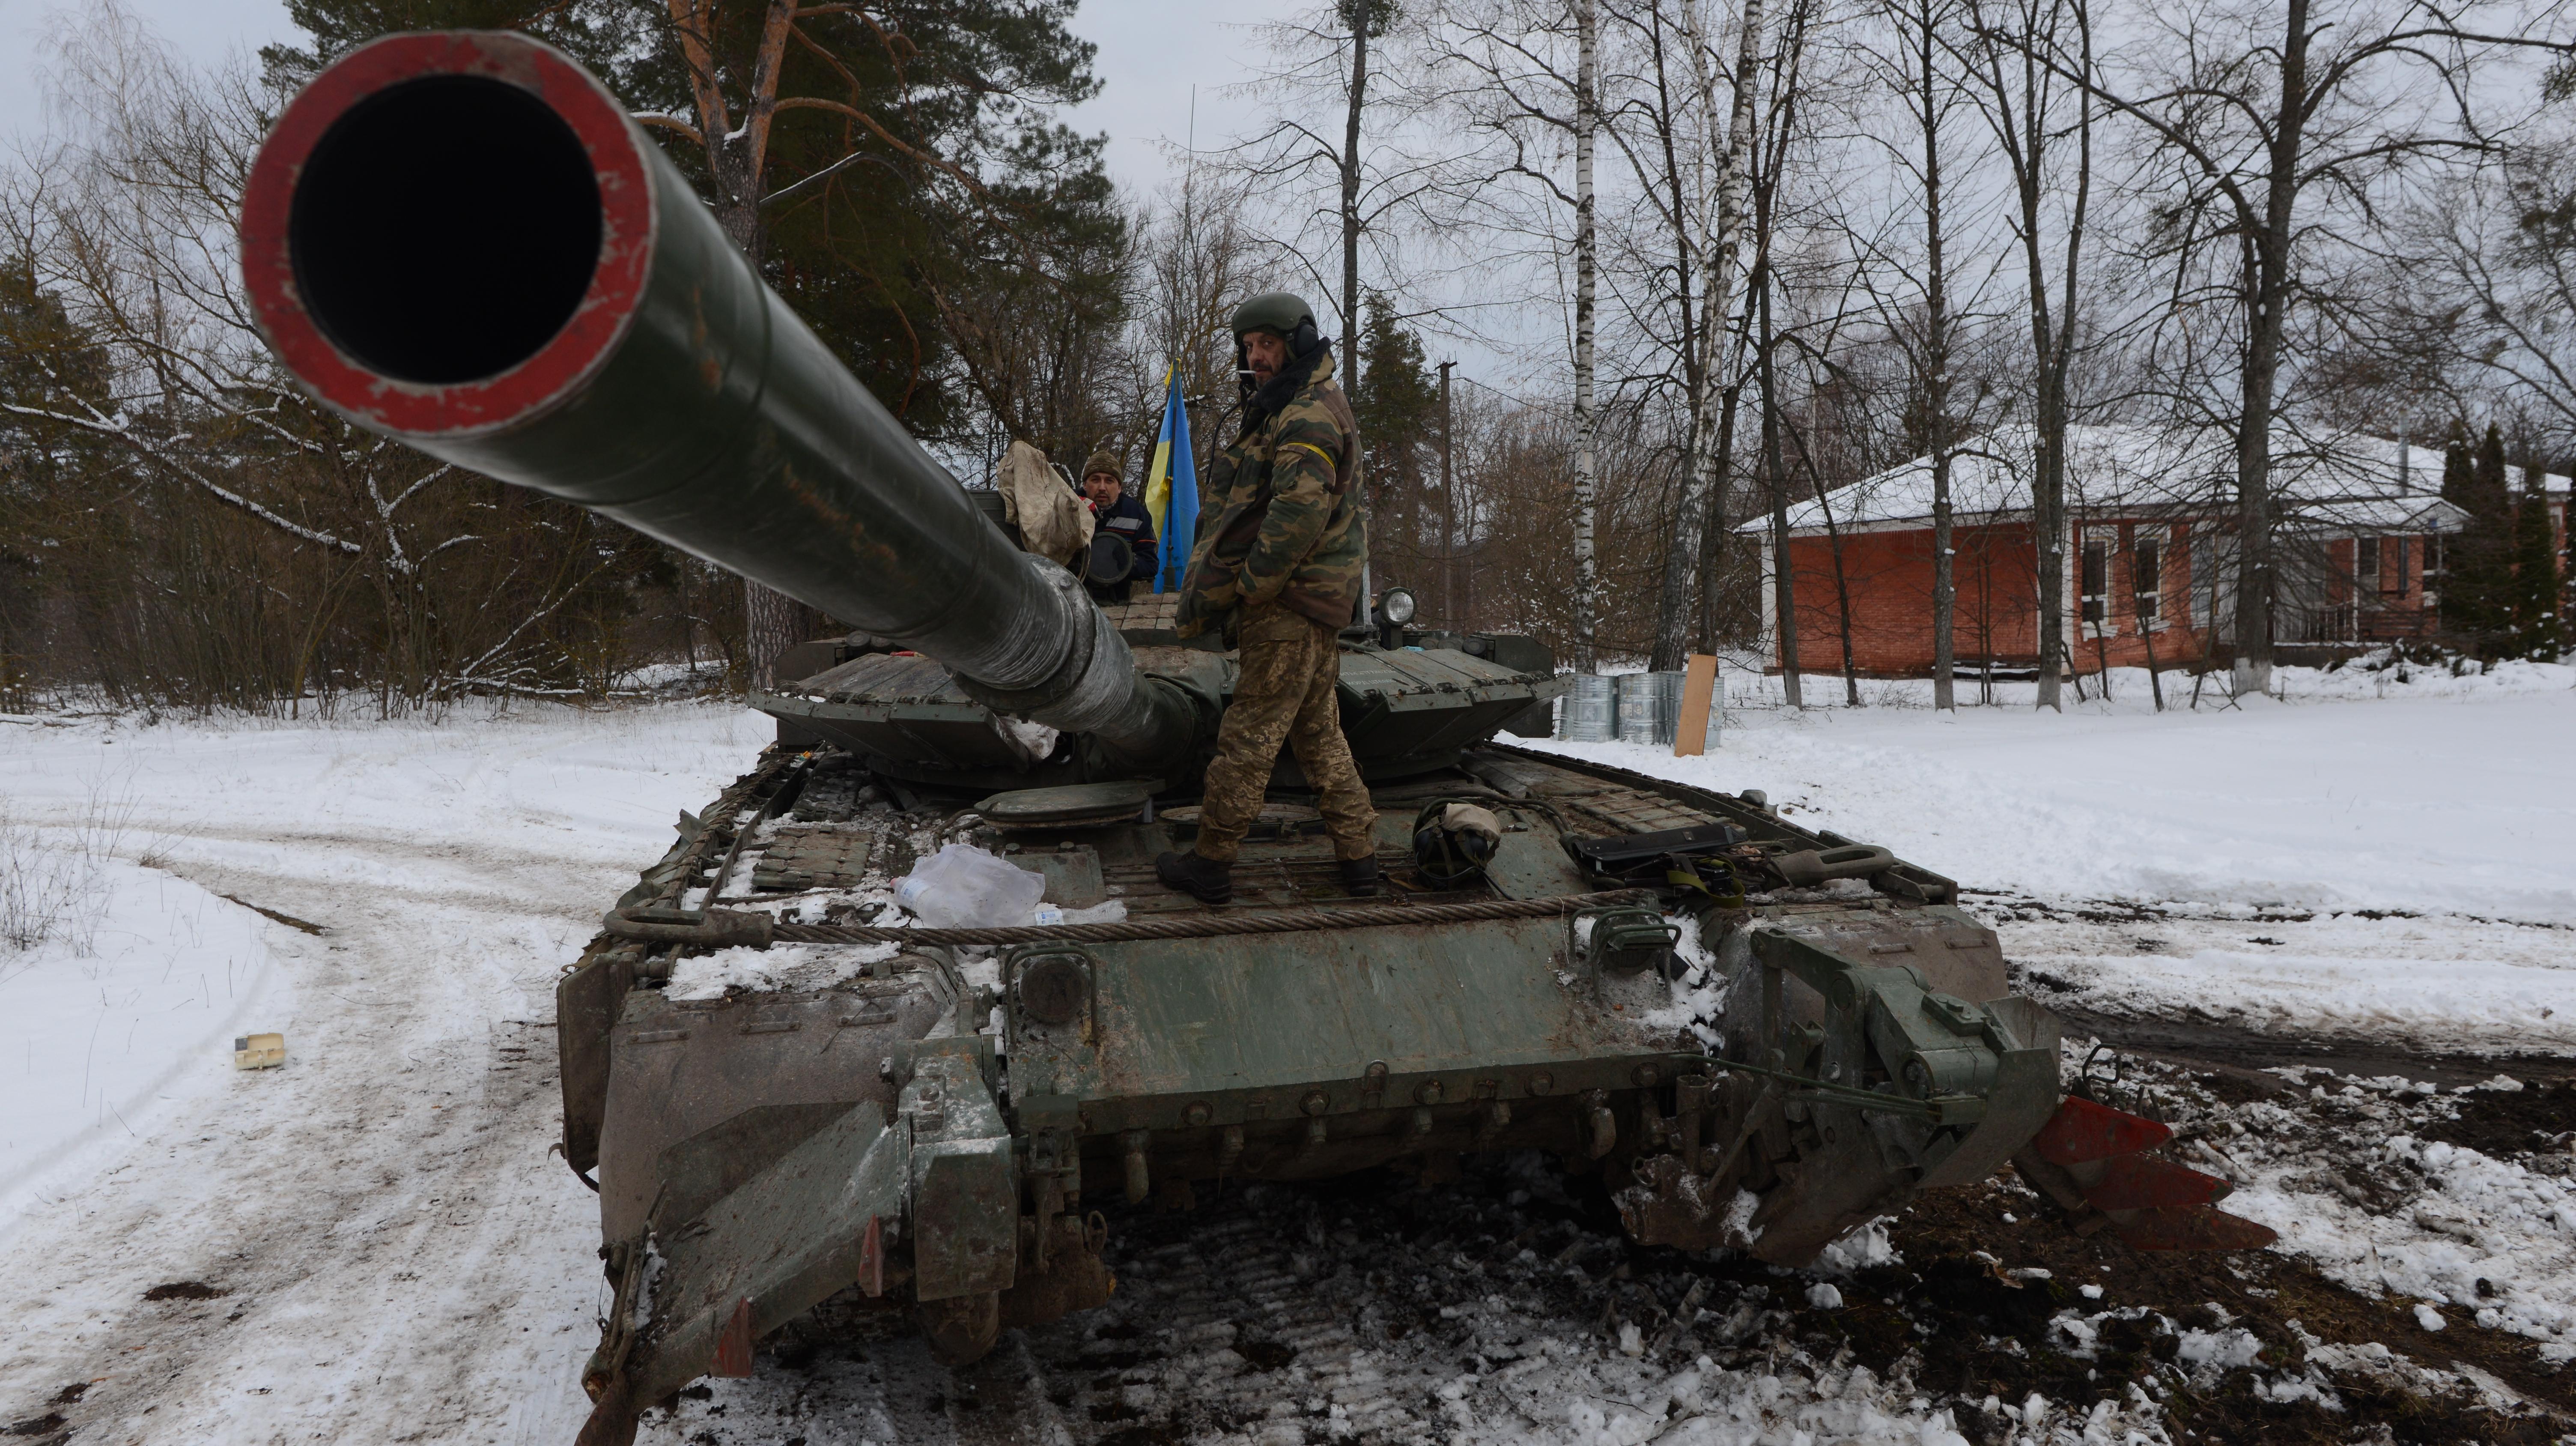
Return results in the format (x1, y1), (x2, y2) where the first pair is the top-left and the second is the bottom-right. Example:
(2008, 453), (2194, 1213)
(1154, 291), (1378, 905)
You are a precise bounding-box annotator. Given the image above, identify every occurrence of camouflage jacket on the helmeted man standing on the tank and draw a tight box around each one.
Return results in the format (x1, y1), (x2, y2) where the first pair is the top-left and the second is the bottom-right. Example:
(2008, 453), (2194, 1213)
(1177, 340), (1368, 636)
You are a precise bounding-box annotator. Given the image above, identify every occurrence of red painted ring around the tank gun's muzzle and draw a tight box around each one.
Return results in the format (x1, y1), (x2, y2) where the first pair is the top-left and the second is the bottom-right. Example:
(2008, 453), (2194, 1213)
(242, 31), (654, 438)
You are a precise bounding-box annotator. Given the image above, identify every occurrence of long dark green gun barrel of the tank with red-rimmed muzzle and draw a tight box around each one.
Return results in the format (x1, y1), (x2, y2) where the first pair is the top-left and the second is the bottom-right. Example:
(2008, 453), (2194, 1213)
(242, 31), (1198, 771)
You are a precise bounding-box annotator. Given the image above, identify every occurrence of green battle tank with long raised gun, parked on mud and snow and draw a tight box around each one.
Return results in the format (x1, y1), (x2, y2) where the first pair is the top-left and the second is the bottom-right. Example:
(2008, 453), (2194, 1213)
(242, 33), (2269, 1443)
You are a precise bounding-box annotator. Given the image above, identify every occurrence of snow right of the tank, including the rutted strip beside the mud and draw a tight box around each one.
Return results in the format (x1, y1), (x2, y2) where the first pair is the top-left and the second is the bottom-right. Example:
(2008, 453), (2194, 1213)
(1538, 654), (2576, 1054)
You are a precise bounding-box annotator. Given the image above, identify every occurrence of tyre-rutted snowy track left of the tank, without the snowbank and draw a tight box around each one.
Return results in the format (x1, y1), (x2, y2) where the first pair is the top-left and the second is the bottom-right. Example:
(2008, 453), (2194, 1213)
(0, 709), (757, 1443)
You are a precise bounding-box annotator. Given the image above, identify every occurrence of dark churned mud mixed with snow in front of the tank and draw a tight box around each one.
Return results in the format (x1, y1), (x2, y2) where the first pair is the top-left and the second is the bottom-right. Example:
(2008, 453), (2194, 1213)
(618, 1016), (2576, 1446)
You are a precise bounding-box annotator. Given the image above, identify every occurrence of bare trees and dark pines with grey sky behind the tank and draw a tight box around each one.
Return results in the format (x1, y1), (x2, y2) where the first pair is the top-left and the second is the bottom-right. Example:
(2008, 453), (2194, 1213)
(0, 0), (2576, 714)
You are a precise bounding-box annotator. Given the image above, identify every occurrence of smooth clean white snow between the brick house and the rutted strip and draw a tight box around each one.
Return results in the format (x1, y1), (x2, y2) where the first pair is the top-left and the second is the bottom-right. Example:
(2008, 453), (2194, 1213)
(1571, 665), (2576, 925)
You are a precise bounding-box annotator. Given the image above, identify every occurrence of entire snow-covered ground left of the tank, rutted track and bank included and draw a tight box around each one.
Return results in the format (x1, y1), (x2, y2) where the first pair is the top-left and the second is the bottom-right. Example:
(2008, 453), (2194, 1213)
(0, 706), (768, 1443)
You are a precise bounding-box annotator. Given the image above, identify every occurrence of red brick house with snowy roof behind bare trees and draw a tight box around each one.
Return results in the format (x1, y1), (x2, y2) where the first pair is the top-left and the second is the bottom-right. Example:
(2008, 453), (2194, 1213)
(1736, 425), (2534, 678)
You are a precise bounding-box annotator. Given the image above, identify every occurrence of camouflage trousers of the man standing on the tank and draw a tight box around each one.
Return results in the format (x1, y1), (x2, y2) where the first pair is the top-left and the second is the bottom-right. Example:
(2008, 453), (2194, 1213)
(1198, 603), (1378, 863)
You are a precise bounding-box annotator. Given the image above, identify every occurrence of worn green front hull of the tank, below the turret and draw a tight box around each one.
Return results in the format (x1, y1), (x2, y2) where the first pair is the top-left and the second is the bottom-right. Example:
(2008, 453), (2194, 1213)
(559, 742), (2277, 1438)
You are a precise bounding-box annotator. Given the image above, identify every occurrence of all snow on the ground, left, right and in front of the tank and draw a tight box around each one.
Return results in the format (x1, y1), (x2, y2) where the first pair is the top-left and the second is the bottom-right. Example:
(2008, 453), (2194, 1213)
(0, 670), (2576, 1446)
